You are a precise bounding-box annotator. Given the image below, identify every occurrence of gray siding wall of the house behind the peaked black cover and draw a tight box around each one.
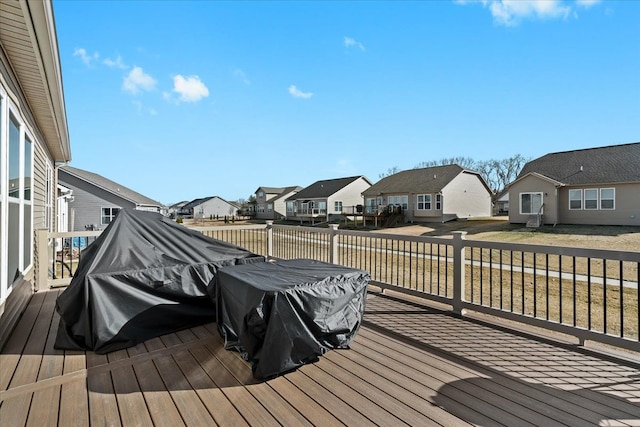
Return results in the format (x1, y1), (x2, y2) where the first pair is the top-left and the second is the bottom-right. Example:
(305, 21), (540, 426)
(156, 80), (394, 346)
(59, 171), (136, 231)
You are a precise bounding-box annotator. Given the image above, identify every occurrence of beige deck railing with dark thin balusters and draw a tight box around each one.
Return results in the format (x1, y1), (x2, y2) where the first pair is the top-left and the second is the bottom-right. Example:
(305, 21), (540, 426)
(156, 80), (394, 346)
(37, 222), (640, 351)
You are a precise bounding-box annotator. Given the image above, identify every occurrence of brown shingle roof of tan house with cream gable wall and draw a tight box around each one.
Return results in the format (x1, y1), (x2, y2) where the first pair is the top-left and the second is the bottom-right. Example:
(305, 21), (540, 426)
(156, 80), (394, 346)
(363, 164), (468, 195)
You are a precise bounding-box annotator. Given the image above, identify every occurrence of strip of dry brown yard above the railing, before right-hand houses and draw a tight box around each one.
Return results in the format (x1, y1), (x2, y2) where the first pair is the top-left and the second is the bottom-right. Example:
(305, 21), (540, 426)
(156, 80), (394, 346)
(375, 218), (640, 251)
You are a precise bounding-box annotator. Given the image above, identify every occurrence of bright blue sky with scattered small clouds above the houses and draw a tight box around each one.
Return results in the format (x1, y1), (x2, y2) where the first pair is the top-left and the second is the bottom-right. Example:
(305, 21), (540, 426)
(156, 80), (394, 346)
(53, 0), (640, 203)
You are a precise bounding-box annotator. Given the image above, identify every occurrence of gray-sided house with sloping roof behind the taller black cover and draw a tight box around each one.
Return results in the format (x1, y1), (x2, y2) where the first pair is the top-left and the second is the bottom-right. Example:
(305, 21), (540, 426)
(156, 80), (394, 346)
(58, 165), (163, 231)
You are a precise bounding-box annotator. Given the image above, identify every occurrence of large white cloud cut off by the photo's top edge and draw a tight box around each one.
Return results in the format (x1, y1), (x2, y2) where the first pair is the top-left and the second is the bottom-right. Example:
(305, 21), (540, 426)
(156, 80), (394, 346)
(455, 0), (601, 26)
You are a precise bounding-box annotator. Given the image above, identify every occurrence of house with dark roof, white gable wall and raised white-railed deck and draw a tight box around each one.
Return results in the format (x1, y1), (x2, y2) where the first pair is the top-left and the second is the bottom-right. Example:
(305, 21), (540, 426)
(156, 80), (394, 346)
(286, 175), (371, 223)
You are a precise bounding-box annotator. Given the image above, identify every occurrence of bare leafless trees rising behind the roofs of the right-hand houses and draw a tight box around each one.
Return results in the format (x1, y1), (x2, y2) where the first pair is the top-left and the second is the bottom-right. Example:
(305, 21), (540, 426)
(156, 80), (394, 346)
(380, 154), (529, 193)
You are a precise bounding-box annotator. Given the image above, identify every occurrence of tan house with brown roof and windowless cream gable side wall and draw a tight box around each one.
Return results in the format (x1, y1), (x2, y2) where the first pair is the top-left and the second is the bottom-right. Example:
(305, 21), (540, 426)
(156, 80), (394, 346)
(362, 164), (492, 225)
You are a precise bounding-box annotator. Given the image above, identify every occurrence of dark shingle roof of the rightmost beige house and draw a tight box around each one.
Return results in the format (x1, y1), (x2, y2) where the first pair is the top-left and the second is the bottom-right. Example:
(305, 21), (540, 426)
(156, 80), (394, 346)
(516, 142), (640, 185)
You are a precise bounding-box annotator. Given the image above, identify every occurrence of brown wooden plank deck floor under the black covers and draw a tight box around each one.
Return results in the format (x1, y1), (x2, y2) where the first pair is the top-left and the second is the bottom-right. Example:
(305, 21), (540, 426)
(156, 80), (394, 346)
(0, 290), (640, 427)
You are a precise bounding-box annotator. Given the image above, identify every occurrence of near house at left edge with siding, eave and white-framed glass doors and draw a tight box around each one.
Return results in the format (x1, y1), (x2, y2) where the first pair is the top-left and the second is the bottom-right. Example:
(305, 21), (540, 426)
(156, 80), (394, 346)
(0, 0), (71, 348)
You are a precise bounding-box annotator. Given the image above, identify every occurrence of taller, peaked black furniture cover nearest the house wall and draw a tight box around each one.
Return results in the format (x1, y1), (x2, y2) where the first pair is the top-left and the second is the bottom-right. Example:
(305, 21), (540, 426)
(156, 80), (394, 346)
(55, 210), (265, 353)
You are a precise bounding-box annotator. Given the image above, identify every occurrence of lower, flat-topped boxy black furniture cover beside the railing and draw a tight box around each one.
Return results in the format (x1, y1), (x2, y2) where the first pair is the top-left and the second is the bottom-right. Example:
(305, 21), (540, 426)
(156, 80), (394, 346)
(216, 259), (370, 379)
